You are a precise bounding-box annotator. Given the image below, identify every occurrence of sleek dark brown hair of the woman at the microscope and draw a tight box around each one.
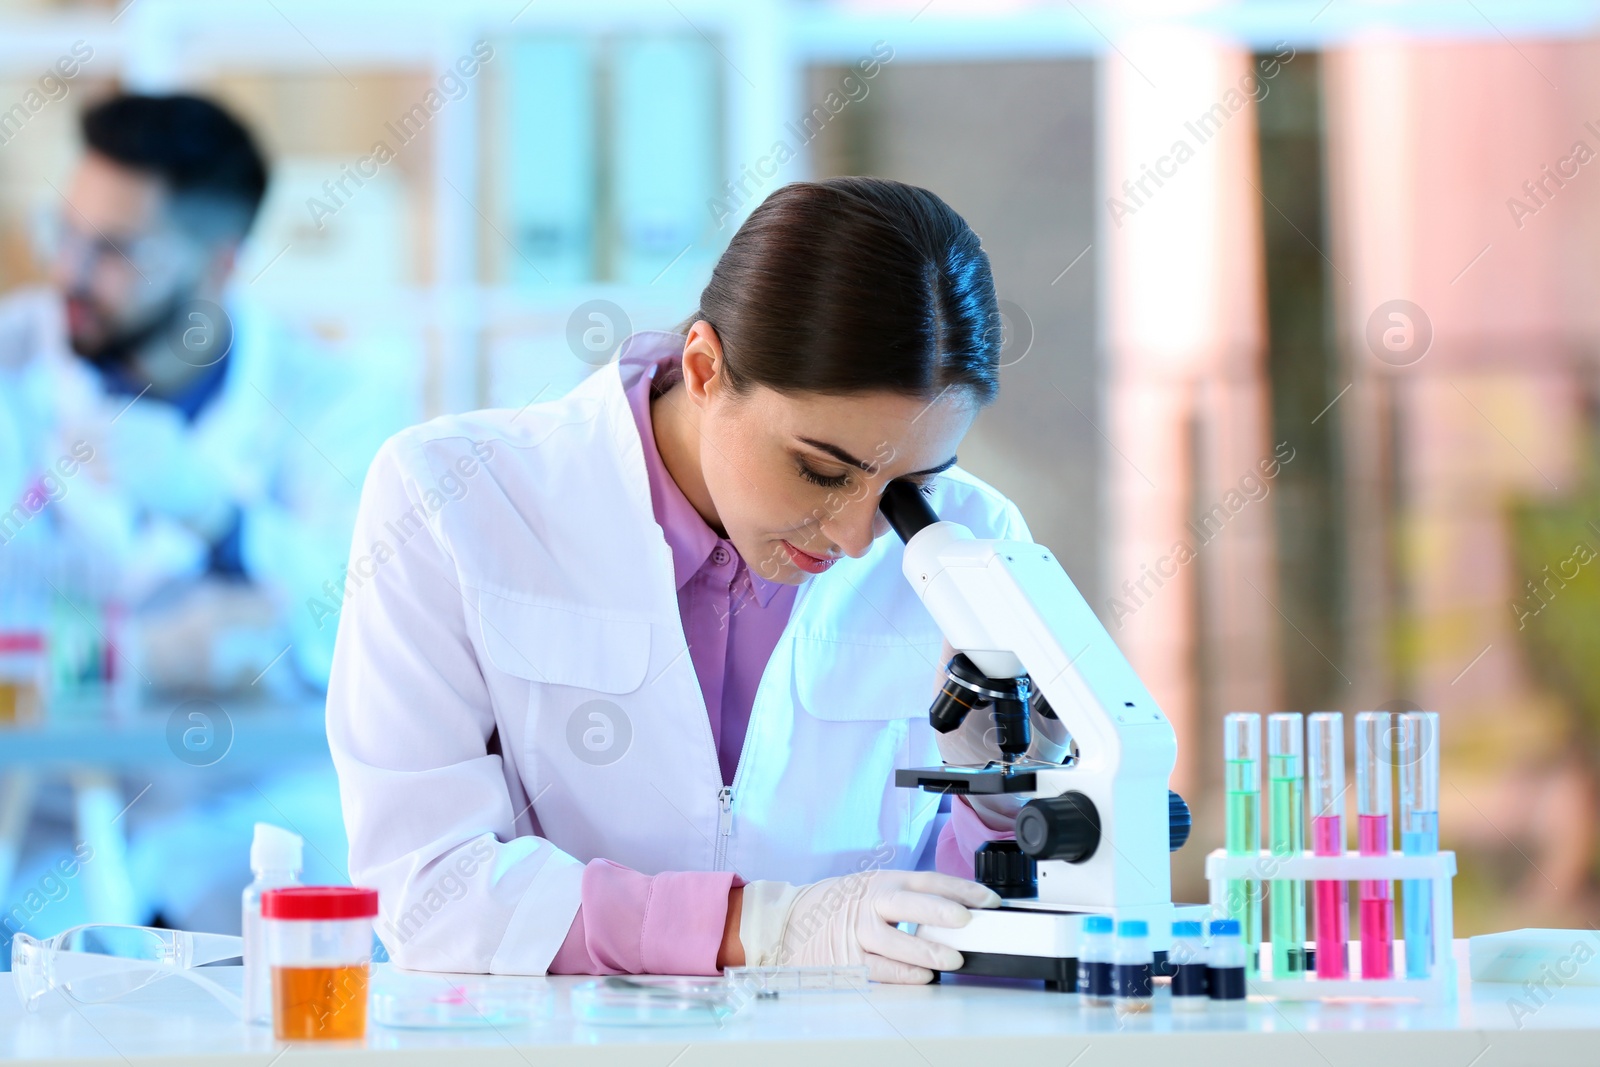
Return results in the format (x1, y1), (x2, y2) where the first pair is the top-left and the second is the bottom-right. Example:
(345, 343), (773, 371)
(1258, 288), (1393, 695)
(683, 178), (1002, 405)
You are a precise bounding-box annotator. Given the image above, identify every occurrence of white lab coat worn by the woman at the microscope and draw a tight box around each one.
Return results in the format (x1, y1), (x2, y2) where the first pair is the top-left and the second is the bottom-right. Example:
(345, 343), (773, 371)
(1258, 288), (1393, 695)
(328, 335), (1029, 974)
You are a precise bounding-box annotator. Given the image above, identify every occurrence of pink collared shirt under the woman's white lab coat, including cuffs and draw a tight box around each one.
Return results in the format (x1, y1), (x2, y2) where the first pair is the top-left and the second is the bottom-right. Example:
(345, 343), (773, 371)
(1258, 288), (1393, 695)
(549, 341), (1010, 974)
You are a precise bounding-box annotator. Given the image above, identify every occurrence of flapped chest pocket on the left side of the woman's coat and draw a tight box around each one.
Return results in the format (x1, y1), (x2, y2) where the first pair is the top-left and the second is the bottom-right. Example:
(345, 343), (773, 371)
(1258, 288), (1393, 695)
(478, 590), (650, 694)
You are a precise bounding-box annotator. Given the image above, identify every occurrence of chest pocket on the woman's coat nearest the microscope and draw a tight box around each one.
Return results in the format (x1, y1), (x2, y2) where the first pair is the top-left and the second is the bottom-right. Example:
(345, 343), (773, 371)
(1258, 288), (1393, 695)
(795, 633), (944, 721)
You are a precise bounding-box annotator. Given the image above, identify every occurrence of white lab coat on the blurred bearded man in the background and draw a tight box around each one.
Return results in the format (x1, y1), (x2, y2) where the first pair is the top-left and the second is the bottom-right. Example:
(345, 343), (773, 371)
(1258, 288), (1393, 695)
(0, 288), (414, 686)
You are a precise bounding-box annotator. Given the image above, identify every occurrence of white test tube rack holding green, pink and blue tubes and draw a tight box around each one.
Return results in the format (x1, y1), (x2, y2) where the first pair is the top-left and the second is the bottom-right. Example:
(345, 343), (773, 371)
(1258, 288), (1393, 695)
(1205, 849), (1456, 1003)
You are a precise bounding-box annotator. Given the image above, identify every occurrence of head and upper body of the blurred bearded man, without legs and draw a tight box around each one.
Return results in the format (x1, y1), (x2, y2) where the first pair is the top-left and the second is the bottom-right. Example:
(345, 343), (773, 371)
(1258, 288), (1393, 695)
(0, 96), (380, 689)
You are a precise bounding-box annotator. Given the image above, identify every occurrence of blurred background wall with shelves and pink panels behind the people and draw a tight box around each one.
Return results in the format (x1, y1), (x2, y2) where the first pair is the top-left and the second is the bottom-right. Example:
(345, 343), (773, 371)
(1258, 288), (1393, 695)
(0, 0), (1600, 933)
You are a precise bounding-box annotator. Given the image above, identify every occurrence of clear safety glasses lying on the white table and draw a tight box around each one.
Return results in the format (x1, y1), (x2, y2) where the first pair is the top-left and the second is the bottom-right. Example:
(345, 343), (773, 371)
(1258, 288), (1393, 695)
(11, 923), (245, 1014)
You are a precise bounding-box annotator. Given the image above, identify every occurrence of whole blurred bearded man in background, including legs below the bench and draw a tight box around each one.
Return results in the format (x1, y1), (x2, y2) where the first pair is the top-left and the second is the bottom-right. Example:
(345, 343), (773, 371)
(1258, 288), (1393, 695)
(0, 94), (396, 933)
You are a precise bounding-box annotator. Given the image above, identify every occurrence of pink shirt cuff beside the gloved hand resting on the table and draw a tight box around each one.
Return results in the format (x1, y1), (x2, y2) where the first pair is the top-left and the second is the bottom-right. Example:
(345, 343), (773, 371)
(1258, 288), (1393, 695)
(549, 859), (744, 974)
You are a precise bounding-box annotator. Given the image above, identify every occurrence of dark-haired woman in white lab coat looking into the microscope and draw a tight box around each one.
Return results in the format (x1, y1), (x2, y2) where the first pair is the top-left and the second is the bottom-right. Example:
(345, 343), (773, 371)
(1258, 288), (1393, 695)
(328, 178), (1061, 982)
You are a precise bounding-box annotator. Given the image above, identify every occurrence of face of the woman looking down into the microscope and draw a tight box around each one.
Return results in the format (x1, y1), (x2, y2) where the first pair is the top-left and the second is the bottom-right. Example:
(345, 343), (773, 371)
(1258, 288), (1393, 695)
(659, 322), (978, 584)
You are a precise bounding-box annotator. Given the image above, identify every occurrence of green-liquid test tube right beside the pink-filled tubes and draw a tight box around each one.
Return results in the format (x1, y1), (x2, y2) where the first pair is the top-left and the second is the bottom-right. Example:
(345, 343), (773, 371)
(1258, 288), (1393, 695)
(1267, 712), (1306, 979)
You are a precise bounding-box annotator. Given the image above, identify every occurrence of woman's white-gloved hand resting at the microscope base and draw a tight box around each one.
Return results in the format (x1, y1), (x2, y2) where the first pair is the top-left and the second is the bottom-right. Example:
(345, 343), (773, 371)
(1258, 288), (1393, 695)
(739, 870), (1000, 985)
